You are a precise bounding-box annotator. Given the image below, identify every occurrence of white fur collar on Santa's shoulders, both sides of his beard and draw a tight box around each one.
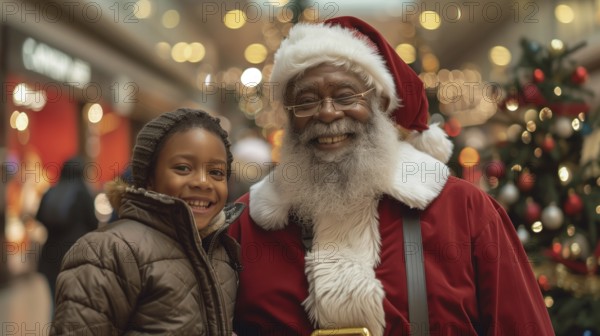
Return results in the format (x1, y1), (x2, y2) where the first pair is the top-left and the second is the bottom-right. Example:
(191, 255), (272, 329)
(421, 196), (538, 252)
(250, 141), (450, 230)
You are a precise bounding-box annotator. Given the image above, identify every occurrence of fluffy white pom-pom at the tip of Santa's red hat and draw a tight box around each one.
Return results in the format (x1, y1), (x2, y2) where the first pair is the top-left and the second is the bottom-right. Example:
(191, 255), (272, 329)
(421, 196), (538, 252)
(406, 123), (454, 163)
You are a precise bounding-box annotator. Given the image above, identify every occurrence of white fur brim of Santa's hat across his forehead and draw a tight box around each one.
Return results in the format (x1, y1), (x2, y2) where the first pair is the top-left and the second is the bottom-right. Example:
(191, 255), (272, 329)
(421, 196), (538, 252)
(270, 23), (399, 112)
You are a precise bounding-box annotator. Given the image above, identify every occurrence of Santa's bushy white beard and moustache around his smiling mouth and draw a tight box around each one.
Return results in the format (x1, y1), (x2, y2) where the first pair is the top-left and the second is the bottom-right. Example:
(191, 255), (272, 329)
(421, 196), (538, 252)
(277, 106), (398, 226)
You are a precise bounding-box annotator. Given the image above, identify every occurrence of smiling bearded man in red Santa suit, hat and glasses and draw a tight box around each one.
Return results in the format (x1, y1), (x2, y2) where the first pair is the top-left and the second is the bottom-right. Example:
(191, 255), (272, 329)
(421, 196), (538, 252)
(229, 17), (553, 336)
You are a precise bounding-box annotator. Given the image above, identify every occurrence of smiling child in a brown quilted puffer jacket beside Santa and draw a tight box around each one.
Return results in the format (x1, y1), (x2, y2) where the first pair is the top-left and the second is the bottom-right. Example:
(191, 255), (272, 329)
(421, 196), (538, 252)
(51, 109), (242, 335)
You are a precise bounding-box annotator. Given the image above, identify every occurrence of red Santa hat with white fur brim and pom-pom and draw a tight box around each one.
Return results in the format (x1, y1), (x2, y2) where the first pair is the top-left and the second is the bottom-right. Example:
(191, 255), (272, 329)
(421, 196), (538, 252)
(270, 16), (453, 162)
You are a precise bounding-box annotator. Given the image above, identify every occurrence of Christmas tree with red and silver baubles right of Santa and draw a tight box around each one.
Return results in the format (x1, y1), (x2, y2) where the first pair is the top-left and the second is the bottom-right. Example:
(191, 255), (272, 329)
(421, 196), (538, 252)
(484, 39), (600, 336)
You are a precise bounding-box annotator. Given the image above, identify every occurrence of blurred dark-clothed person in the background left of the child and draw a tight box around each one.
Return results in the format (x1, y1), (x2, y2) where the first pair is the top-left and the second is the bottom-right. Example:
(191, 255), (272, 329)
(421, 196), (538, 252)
(35, 156), (98, 297)
